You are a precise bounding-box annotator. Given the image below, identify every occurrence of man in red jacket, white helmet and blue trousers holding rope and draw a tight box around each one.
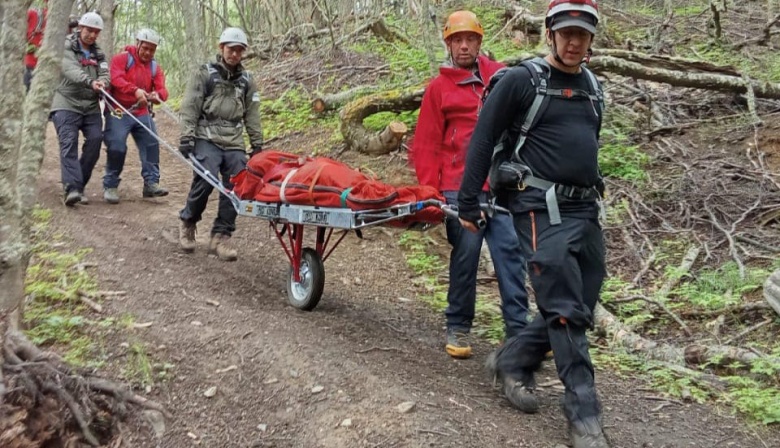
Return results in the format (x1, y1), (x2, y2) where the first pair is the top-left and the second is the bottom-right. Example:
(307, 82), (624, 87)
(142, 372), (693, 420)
(103, 29), (168, 204)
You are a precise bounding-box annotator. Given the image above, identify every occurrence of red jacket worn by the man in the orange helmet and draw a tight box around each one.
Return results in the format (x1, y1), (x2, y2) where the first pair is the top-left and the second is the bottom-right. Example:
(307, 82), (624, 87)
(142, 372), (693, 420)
(410, 56), (504, 191)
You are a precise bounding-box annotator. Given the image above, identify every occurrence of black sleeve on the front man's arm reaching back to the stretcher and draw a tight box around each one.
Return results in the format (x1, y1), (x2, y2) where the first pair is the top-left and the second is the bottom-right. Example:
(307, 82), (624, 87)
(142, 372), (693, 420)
(458, 67), (534, 222)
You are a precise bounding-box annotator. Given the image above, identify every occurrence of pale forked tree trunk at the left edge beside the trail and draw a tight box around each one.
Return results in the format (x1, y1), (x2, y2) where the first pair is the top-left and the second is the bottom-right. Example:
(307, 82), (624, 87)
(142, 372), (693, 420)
(0, 0), (73, 401)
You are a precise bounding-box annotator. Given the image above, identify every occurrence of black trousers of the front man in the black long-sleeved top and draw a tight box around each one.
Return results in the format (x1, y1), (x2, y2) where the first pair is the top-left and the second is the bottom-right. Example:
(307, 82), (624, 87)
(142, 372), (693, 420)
(498, 211), (606, 421)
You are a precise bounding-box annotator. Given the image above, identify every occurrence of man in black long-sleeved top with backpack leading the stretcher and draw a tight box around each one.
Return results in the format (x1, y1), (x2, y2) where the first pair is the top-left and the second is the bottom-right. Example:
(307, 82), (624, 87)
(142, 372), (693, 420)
(458, 0), (609, 448)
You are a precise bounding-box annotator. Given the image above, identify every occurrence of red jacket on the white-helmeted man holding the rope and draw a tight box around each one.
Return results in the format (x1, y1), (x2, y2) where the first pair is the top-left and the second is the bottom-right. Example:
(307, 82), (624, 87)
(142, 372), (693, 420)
(111, 45), (168, 117)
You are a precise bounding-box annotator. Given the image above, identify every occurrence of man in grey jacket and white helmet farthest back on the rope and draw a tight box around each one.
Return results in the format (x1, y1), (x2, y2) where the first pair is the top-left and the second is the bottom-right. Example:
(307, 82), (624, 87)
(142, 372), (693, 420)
(51, 12), (109, 207)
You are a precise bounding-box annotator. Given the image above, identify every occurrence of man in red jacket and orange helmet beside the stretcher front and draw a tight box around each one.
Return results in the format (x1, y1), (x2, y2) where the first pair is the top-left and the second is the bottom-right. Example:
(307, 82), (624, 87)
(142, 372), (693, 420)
(412, 11), (528, 358)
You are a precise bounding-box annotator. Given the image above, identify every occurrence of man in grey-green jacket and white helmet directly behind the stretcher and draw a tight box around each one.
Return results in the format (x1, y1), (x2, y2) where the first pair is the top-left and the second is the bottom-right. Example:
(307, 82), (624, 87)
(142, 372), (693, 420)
(179, 28), (263, 261)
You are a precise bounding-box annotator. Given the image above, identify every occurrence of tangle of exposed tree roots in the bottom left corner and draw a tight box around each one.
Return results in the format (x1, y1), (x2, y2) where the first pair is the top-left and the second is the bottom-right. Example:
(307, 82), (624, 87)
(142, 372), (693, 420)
(0, 331), (171, 448)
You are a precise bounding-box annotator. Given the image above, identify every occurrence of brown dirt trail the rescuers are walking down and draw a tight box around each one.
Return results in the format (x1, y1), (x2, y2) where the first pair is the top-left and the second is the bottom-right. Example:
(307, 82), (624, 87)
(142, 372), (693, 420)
(33, 117), (777, 448)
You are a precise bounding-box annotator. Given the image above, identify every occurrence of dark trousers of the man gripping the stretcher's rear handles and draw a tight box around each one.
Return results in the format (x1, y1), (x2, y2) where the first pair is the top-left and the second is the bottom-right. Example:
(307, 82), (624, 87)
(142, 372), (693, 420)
(179, 139), (248, 236)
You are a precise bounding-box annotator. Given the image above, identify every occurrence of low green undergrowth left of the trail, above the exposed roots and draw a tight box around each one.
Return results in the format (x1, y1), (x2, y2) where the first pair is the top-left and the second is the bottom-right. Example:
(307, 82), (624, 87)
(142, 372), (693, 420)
(23, 208), (174, 387)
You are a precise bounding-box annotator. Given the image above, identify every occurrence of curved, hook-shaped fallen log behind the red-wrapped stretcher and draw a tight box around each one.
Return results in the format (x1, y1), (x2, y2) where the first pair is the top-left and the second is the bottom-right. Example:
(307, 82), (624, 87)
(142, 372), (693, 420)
(339, 89), (424, 155)
